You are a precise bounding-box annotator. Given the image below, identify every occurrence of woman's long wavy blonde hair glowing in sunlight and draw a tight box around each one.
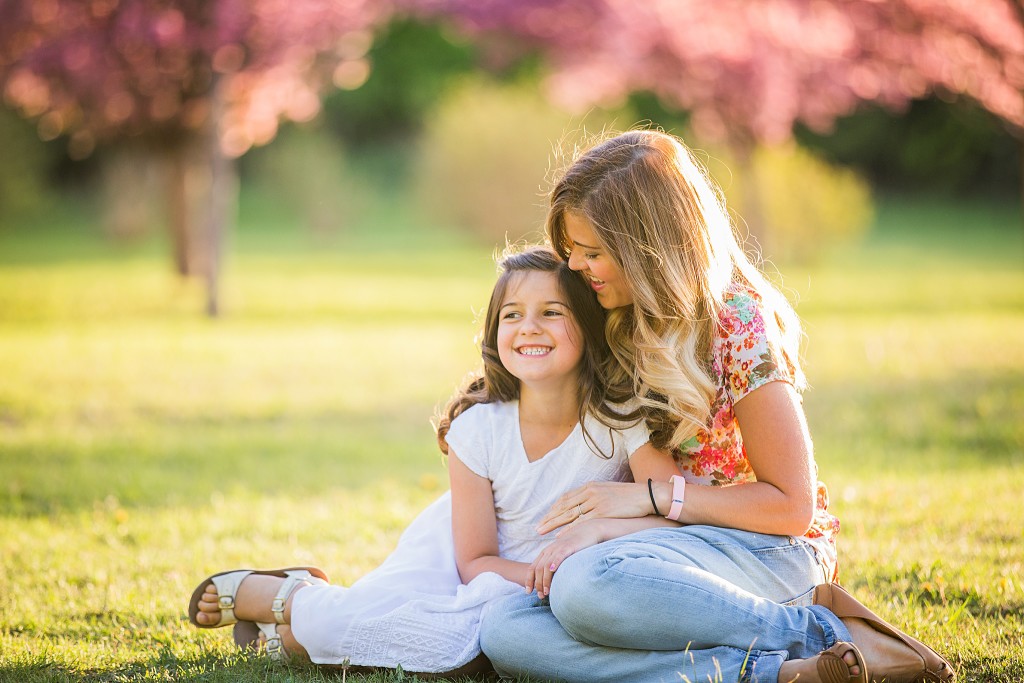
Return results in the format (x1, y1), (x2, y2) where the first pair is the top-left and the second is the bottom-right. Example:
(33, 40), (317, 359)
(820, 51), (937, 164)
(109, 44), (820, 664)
(547, 130), (804, 447)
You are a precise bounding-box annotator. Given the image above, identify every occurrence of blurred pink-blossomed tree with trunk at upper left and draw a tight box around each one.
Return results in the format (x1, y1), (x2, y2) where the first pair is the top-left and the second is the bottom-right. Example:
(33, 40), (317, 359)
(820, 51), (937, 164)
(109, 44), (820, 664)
(0, 0), (391, 315)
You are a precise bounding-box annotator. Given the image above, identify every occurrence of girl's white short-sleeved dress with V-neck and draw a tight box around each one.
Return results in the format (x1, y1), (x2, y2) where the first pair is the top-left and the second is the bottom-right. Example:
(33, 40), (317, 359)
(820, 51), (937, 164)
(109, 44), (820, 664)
(292, 401), (649, 672)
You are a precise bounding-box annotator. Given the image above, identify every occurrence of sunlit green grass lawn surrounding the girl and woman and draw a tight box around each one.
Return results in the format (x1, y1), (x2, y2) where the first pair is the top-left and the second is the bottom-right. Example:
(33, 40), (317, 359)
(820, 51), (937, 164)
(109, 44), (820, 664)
(0, 193), (1024, 683)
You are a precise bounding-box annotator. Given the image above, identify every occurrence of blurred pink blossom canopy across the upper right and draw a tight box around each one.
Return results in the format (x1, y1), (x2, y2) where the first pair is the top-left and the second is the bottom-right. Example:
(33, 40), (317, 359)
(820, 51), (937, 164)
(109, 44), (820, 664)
(411, 0), (1024, 240)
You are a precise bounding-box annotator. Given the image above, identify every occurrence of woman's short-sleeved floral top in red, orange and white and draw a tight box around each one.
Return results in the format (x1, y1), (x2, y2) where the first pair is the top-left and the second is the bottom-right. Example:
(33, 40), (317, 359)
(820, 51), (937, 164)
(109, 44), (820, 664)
(675, 285), (839, 579)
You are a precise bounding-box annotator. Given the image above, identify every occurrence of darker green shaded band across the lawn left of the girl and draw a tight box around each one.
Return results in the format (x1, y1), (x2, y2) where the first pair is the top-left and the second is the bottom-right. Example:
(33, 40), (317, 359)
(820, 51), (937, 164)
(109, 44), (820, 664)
(0, 414), (446, 516)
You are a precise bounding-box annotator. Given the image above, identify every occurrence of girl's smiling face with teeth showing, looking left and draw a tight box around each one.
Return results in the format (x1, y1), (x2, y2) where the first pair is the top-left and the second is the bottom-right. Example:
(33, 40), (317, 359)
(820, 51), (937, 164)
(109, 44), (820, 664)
(498, 271), (583, 386)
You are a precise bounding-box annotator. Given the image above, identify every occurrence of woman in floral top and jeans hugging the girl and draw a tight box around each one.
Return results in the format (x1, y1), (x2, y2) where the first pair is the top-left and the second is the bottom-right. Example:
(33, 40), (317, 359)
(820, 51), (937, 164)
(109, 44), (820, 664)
(481, 131), (954, 683)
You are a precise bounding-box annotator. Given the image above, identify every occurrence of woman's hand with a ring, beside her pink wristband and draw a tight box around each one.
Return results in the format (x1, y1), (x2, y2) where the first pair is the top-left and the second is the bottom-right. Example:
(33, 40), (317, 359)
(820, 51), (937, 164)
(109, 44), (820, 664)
(537, 481), (655, 535)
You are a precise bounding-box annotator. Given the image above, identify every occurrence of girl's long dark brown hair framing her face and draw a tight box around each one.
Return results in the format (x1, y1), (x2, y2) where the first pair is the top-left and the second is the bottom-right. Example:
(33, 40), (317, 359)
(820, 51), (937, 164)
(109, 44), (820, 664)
(436, 247), (639, 457)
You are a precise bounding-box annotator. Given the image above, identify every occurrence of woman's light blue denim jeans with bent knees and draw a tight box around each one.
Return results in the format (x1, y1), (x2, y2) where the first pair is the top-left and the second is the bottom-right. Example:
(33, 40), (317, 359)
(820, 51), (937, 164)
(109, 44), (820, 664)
(480, 526), (850, 683)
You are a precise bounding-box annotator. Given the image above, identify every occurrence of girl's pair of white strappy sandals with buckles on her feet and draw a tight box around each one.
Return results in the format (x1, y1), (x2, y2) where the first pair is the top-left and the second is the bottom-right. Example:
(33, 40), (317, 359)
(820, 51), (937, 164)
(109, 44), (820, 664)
(188, 567), (328, 660)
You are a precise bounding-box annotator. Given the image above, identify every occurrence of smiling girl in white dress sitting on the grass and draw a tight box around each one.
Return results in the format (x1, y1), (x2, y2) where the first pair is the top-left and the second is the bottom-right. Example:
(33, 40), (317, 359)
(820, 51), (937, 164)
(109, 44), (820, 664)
(188, 248), (678, 673)
